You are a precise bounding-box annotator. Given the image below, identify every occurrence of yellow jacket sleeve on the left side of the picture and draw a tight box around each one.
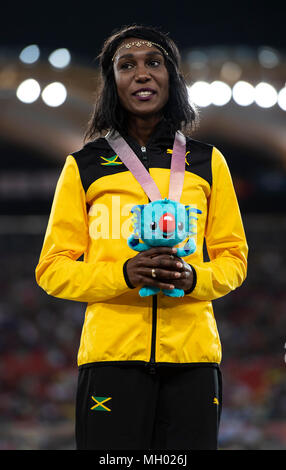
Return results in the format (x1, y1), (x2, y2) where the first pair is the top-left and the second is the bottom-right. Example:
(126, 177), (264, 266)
(35, 155), (132, 303)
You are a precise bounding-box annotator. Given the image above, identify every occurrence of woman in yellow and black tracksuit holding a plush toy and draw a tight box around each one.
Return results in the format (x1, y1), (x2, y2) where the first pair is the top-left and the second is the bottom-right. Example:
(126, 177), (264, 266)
(36, 26), (247, 449)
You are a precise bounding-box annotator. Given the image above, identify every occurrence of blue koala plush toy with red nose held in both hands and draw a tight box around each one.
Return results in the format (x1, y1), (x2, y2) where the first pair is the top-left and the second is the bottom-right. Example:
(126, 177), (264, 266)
(127, 198), (201, 297)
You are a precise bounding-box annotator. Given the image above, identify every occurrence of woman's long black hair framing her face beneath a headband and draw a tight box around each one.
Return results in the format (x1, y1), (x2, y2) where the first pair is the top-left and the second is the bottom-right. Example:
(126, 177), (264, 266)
(85, 25), (198, 141)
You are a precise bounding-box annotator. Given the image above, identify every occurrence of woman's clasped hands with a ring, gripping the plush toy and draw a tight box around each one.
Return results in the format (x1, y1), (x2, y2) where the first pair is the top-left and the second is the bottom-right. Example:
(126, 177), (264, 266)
(126, 247), (193, 290)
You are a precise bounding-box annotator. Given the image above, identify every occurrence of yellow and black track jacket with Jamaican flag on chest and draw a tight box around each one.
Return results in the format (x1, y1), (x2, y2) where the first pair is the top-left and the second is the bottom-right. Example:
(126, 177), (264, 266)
(36, 121), (248, 367)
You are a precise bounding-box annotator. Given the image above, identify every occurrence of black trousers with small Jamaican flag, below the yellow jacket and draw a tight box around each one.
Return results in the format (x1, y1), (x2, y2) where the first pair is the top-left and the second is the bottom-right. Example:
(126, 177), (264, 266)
(76, 364), (222, 450)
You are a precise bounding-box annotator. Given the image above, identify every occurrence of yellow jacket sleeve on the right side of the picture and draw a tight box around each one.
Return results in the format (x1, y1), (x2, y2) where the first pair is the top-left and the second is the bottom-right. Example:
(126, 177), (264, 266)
(188, 147), (248, 300)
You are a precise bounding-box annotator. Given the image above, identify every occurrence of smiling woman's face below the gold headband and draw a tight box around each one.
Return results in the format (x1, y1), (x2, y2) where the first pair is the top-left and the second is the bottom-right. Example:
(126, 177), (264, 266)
(113, 38), (169, 117)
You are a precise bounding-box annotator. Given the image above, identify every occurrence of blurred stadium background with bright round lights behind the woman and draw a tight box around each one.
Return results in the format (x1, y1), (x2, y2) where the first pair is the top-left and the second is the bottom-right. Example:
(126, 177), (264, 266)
(0, 1), (286, 450)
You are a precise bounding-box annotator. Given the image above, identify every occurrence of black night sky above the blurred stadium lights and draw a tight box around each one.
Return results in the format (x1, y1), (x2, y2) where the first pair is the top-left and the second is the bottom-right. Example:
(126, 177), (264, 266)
(1, 0), (286, 58)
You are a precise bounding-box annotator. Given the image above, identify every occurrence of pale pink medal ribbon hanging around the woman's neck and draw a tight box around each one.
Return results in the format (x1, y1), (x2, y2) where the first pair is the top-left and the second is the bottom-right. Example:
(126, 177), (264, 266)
(105, 131), (186, 202)
